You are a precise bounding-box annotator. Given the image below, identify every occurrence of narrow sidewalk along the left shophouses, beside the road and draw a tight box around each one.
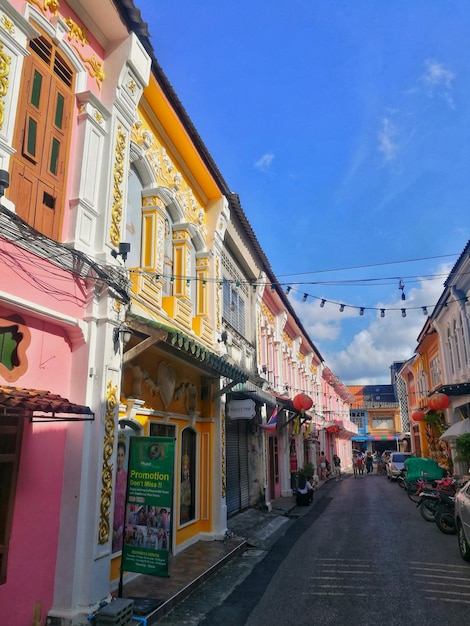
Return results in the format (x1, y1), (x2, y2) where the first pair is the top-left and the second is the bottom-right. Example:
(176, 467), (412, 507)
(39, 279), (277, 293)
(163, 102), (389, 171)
(117, 484), (330, 626)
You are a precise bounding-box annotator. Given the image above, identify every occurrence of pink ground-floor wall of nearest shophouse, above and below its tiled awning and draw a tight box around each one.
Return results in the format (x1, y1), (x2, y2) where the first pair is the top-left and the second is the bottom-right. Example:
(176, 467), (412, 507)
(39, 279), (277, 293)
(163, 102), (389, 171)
(0, 240), (86, 625)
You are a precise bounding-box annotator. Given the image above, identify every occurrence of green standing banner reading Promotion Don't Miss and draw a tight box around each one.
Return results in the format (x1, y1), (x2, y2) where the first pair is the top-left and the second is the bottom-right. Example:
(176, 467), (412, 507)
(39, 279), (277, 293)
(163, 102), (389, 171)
(121, 437), (175, 577)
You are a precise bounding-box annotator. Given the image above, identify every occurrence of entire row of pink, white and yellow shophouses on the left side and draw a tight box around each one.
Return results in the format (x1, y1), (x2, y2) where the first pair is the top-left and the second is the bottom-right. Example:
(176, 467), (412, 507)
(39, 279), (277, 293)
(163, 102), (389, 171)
(0, 0), (355, 626)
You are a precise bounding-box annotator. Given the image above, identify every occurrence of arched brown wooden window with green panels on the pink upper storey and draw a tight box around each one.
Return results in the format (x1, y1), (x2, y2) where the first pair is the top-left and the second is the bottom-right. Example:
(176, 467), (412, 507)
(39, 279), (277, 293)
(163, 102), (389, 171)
(8, 29), (75, 241)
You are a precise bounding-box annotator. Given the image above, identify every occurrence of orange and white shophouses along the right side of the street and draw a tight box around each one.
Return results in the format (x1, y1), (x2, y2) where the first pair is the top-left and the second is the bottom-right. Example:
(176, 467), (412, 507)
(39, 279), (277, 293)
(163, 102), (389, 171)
(400, 242), (470, 474)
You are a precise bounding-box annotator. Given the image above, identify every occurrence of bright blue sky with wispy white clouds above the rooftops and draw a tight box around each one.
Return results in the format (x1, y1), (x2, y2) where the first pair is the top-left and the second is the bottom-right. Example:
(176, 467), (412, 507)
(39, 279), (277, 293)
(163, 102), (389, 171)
(135, 0), (470, 384)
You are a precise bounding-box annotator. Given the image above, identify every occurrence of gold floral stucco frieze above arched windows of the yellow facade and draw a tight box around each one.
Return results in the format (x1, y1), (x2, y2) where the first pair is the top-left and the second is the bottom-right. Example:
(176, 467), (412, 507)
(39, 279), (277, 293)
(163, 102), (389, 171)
(132, 119), (206, 236)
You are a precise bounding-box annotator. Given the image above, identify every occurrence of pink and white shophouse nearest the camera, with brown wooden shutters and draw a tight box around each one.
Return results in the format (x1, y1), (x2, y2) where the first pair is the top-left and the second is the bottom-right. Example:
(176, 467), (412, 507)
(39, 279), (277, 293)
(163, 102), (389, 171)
(0, 0), (150, 624)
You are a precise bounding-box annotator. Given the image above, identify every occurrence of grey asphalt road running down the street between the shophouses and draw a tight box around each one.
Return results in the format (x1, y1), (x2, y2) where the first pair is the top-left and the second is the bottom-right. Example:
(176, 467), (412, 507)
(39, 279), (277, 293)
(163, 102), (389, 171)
(159, 474), (470, 626)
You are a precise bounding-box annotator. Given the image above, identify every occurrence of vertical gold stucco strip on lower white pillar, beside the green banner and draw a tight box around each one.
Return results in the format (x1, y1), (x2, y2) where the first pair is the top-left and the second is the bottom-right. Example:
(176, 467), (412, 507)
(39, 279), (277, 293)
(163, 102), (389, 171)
(98, 382), (118, 544)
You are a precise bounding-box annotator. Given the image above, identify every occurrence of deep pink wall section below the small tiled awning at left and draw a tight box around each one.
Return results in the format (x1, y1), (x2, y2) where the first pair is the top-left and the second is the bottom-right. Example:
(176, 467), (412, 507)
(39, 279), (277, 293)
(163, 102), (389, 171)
(0, 421), (66, 626)
